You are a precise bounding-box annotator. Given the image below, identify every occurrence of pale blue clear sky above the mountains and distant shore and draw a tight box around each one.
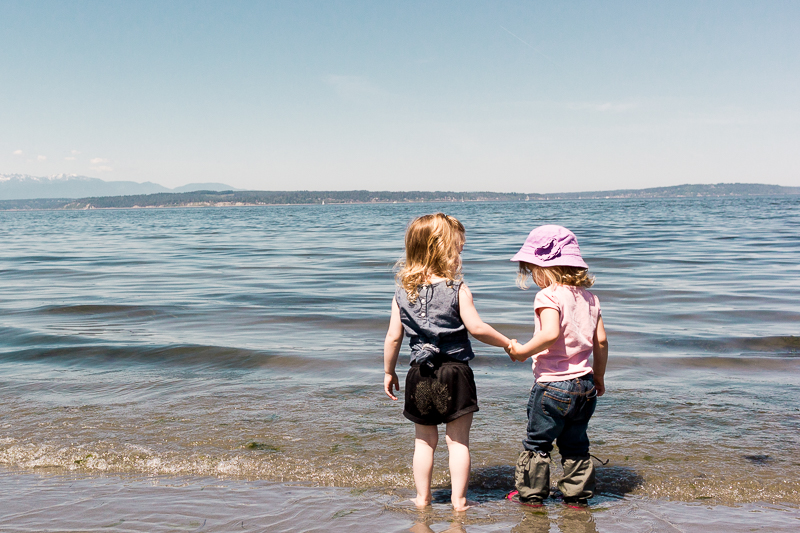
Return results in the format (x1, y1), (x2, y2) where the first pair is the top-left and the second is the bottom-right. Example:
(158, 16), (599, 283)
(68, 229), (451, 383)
(0, 0), (800, 193)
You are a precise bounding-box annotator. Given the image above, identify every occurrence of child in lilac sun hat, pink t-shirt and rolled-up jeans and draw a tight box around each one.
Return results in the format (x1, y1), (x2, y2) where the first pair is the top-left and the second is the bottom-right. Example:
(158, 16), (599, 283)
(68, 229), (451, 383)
(506, 225), (608, 506)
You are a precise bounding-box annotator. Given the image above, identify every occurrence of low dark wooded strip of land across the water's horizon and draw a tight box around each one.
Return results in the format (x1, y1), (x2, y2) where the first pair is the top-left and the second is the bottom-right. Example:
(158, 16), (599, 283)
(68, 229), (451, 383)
(0, 183), (800, 211)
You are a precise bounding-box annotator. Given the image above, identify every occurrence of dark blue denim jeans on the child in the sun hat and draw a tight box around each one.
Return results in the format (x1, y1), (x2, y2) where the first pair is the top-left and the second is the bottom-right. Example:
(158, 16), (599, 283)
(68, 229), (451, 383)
(522, 374), (597, 457)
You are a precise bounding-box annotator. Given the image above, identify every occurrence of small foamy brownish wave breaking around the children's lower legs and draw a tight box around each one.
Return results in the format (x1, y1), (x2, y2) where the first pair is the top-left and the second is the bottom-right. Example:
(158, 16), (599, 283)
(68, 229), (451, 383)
(0, 439), (800, 504)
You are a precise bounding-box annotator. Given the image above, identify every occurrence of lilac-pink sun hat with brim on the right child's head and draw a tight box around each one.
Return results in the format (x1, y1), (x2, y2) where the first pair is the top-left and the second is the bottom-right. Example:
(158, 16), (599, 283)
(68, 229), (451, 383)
(511, 225), (589, 268)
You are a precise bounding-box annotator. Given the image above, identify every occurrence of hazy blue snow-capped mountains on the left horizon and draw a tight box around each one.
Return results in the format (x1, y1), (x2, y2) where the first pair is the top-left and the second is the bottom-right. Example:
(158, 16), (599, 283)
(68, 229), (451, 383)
(0, 174), (237, 200)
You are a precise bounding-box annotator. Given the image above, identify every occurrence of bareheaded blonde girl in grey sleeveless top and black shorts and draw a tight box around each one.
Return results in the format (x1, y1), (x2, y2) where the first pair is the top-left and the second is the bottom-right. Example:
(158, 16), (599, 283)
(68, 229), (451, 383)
(383, 213), (510, 511)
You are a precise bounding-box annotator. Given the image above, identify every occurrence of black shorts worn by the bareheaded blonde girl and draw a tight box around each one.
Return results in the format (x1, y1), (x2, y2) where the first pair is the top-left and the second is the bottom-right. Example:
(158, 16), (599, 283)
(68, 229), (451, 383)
(403, 359), (478, 426)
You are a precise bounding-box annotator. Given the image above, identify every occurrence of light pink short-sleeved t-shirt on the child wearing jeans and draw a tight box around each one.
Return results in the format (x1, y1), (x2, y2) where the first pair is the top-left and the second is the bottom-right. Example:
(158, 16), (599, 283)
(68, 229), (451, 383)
(533, 285), (600, 381)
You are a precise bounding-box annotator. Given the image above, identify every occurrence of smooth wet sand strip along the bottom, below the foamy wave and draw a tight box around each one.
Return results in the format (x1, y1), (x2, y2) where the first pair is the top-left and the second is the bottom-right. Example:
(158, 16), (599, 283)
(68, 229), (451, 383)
(0, 469), (800, 533)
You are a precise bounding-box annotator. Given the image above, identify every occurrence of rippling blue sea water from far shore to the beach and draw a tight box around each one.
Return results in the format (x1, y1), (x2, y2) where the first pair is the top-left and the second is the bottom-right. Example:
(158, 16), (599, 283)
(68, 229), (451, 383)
(0, 196), (800, 532)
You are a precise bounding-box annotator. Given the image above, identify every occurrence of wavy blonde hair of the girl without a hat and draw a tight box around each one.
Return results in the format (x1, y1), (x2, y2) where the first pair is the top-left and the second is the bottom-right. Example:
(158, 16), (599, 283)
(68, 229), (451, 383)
(395, 213), (466, 303)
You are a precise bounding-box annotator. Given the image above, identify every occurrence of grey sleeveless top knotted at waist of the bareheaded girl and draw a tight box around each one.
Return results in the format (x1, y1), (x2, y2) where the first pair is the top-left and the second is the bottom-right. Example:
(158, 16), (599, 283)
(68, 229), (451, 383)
(394, 281), (475, 363)
